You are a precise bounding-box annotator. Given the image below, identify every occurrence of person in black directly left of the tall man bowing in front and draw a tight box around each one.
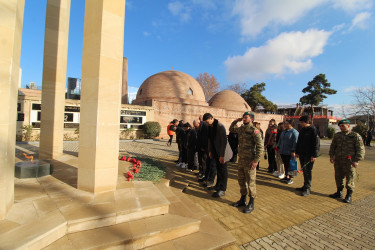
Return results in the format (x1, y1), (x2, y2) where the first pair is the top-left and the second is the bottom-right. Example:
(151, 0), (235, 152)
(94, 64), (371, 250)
(193, 120), (208, 182)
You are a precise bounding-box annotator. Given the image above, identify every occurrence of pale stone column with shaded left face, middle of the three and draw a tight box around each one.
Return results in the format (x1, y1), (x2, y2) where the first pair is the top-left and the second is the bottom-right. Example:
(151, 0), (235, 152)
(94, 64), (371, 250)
(39, 0), (70, 160)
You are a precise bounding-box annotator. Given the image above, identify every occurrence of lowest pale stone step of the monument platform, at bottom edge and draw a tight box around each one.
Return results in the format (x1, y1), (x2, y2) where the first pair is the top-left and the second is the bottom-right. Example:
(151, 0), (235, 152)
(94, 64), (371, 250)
(46, 214), (200, 249)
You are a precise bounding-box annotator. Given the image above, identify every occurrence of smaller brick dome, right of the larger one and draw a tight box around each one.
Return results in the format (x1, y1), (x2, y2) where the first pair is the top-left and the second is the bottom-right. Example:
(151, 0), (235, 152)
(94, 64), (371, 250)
(208, 90), (251, 111)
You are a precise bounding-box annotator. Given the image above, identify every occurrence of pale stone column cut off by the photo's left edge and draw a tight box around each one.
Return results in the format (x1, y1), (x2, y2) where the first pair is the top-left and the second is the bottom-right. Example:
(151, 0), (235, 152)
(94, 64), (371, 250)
(0, 0), (25, 220)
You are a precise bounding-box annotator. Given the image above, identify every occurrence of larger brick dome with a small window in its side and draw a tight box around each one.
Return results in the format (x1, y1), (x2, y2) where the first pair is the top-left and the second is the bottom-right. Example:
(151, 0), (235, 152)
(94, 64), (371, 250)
(133, 70), (208, 106)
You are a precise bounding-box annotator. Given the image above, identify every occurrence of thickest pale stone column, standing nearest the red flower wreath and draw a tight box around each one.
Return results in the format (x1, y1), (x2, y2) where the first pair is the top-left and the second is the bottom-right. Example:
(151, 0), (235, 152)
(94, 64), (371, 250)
(78, 0), (125, 193)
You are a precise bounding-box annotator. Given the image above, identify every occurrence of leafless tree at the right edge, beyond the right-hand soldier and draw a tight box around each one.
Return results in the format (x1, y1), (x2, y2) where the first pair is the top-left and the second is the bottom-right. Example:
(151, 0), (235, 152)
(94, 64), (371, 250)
(353, 84), (375, 128)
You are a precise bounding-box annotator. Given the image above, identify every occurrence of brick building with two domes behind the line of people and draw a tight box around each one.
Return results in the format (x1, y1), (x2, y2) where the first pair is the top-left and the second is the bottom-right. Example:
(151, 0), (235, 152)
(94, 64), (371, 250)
(132, 70), (282, 138)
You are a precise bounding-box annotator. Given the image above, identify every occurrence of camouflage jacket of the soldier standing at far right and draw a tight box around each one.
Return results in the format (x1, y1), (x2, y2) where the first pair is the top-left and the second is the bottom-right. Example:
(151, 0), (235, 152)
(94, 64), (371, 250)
(329, 131), (365, 162)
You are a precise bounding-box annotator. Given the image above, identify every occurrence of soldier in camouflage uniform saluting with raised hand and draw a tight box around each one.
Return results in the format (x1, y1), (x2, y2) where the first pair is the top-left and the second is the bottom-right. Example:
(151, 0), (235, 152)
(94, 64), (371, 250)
(229, 112), (263, 213)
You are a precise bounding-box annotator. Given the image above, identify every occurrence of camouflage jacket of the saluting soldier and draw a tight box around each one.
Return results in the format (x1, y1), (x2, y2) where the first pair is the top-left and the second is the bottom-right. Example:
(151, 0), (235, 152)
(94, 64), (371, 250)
(229, 121), (263, 162)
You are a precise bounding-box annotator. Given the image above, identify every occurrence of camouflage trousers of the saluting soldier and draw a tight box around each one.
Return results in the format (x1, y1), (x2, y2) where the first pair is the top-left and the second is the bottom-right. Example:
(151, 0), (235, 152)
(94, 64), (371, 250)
(238, 157), (257, 198)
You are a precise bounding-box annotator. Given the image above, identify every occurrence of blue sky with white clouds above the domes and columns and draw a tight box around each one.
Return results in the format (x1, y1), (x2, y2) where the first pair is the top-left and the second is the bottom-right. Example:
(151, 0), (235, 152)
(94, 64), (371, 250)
(21, 0), (375, 114)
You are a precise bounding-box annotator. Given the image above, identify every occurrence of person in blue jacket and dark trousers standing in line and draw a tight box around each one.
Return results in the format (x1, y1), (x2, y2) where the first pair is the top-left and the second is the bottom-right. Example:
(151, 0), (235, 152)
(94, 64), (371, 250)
(277, 119), (298, 184)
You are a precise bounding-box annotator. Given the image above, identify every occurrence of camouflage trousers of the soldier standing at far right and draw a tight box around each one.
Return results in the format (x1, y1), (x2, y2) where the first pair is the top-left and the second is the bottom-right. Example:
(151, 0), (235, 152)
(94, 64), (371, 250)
(334, 159), (356, 191)
